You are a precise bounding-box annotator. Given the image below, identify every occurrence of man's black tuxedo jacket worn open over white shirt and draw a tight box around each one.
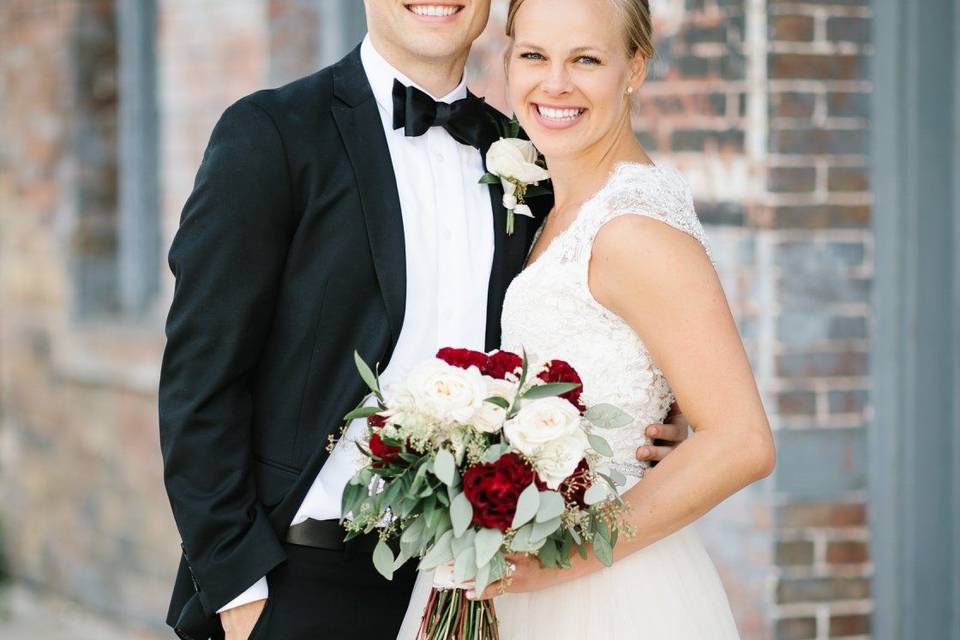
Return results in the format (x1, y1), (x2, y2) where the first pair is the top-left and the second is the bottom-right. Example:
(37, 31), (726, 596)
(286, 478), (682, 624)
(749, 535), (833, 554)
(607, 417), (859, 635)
(159, 49), (549, 637)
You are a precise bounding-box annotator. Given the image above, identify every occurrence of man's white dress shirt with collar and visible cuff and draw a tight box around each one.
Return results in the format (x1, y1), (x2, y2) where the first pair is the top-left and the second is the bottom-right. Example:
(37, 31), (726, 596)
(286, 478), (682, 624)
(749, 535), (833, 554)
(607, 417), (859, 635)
(218, 35), (494, 613)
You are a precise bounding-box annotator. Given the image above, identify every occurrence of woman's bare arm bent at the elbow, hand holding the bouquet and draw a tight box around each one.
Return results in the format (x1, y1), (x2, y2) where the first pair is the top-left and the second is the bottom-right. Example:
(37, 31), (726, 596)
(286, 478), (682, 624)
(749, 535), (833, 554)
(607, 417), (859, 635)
(472, 215), (775, 594)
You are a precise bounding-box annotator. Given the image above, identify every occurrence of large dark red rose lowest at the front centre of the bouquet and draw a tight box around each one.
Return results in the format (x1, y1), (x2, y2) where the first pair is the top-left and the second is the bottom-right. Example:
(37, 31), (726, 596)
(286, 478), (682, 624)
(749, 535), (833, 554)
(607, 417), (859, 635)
(463, 453), (534, 531)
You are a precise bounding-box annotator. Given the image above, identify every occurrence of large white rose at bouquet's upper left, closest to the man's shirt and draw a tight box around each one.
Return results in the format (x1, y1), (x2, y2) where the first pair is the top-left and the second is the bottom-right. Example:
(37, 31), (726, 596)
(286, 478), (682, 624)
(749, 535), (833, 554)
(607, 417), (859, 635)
(407, 359), (487, 423)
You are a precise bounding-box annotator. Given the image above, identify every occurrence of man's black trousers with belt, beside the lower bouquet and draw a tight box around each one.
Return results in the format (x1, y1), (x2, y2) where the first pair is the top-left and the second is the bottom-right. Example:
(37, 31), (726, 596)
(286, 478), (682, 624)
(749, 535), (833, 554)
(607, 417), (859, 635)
(250, 544), (417, 640)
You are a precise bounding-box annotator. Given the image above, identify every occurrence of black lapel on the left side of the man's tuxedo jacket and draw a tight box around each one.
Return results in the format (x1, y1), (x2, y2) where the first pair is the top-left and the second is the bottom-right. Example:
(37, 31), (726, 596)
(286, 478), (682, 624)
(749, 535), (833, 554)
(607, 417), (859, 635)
(332, 47), (407, 344)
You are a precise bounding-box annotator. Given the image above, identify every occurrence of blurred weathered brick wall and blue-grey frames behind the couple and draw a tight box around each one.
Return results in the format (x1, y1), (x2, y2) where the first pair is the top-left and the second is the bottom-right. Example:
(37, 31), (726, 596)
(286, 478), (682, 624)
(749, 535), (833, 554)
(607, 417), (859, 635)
(0, 0), (960, 640)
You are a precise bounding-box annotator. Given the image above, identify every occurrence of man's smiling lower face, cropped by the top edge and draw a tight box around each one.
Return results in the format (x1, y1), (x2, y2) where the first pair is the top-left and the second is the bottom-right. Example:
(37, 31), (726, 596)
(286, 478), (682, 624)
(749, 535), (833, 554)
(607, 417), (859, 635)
(365, 0), (490, 62)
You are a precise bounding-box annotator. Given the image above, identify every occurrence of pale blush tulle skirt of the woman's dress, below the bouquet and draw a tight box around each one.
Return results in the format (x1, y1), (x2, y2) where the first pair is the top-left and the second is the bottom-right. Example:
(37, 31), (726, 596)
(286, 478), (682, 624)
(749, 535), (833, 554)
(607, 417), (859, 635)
(398, 527), (740, 640)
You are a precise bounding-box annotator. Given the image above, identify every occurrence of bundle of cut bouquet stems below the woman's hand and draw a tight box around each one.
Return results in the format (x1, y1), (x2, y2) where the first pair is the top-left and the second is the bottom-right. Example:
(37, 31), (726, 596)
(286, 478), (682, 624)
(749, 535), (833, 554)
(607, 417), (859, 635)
(417, 588), (500, 640)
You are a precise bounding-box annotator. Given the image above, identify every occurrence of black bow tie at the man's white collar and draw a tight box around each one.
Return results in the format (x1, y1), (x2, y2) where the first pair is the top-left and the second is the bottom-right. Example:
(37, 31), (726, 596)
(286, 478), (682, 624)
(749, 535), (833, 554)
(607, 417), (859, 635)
(393, 80), (495, 149)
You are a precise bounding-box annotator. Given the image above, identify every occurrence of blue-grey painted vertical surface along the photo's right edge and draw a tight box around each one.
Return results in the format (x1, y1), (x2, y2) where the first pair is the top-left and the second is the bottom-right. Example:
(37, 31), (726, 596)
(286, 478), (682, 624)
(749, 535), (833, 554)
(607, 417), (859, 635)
(869, 0), (960, 640)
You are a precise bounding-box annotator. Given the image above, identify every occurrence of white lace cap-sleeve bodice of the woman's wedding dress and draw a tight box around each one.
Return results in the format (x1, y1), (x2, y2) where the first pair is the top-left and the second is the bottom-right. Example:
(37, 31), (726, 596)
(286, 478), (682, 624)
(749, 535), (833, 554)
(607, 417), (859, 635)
(502, 163), (709, 484)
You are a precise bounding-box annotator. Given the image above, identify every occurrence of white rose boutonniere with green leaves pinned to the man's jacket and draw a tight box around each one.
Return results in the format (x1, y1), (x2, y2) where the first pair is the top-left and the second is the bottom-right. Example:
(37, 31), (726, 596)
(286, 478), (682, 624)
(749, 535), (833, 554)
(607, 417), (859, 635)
(480, 138), (550, 235)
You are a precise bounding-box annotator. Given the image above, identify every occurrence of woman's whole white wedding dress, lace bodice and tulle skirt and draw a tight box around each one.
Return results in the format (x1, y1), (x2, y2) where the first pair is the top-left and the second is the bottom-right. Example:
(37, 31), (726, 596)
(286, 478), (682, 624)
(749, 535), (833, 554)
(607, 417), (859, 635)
(399, 163), (739, 640)
